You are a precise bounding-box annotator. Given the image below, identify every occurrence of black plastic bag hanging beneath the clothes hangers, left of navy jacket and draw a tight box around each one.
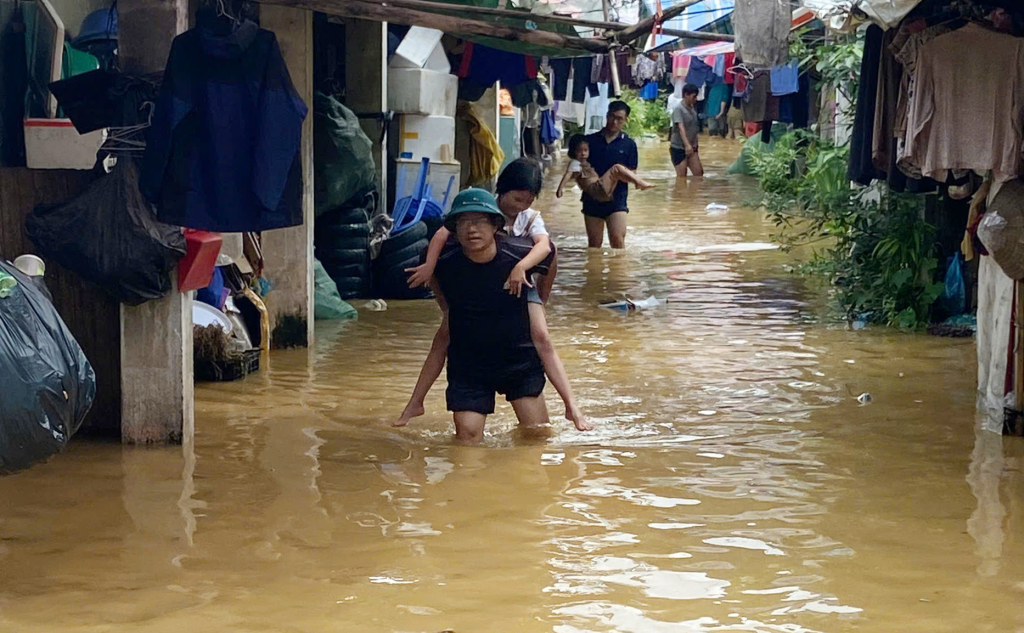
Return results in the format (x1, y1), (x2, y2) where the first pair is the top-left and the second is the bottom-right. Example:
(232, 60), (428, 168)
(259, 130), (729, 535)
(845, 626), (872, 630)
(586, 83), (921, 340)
(26, 159), (185, 305)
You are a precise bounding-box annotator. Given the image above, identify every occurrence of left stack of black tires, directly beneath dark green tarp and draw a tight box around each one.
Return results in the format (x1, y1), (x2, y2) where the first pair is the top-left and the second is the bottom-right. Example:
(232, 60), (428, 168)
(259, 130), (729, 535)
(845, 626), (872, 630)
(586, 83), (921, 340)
(313, 195), (375, 299)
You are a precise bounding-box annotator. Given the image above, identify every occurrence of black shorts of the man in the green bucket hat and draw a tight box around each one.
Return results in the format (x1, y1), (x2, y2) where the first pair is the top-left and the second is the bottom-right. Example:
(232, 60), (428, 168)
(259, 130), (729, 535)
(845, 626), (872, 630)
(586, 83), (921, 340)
(444, 350), (547, 416)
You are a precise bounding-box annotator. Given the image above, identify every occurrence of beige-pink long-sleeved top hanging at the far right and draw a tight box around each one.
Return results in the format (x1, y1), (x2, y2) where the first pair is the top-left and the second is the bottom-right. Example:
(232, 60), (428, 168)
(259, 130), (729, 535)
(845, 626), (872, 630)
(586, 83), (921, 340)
(906, 24), (1024, 181)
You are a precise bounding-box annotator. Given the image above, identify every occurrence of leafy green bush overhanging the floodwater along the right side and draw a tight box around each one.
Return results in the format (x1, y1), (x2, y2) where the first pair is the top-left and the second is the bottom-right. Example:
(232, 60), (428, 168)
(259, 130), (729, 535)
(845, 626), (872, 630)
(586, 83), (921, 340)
(752, 130), (943, 329)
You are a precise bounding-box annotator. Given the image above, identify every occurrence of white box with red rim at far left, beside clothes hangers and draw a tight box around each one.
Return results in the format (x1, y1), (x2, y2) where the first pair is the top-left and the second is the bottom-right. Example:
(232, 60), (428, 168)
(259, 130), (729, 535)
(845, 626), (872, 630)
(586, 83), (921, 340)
(25, 119), (106, 169)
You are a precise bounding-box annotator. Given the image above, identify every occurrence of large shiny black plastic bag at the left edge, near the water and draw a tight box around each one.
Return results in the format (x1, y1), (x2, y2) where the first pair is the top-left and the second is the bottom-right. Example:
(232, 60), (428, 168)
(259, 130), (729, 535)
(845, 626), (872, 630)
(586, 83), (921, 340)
(0, 257), (96, 474)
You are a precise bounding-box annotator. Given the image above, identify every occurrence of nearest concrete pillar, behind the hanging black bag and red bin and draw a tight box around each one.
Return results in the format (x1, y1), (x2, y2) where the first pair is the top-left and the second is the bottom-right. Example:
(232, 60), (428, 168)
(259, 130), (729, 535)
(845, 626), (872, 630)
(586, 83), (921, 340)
(118, 0), (195, 444)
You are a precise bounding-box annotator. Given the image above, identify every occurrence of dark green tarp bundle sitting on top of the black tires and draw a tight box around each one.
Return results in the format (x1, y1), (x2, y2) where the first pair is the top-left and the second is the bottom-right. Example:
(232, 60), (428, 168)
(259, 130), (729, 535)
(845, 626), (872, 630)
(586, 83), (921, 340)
(313, 92), (377, 216)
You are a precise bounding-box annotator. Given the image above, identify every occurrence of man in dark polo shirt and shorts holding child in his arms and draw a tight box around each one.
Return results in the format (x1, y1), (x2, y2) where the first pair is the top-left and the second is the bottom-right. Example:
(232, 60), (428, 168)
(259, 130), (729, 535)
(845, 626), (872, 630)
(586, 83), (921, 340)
(583, 101), (639, 248)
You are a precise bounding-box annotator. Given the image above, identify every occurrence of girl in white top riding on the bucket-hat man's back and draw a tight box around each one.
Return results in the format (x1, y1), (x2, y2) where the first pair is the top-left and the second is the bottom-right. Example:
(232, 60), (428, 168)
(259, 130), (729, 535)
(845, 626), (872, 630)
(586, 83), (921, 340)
(394, 158), (593, 431)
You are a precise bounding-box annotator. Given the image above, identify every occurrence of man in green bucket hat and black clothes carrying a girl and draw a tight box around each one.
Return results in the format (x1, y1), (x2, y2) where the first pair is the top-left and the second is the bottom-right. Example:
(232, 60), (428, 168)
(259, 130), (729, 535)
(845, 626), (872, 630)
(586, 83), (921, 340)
(399, 188), (590, 442)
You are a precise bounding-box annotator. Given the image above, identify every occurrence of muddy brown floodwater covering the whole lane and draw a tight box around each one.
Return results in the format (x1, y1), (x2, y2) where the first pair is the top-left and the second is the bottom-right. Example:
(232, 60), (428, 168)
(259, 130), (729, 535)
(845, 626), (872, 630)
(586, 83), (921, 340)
(0, 141), (1024, 633)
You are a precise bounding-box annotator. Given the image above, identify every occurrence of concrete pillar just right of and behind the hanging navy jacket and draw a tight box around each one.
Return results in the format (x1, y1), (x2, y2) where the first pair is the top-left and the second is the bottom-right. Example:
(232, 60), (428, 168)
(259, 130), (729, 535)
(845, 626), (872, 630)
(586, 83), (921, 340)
(260, 4), (313, 347)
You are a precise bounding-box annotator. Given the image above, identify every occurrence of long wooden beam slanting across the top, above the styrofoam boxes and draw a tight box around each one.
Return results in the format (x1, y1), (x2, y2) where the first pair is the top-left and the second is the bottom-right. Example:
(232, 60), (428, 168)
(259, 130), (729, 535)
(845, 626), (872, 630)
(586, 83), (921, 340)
(256, 0), (608, 53)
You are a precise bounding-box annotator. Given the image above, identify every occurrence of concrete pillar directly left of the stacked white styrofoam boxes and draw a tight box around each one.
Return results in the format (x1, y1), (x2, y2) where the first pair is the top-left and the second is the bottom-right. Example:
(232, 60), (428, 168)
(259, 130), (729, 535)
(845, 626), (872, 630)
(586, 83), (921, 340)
(345, 19), (388, 204)
